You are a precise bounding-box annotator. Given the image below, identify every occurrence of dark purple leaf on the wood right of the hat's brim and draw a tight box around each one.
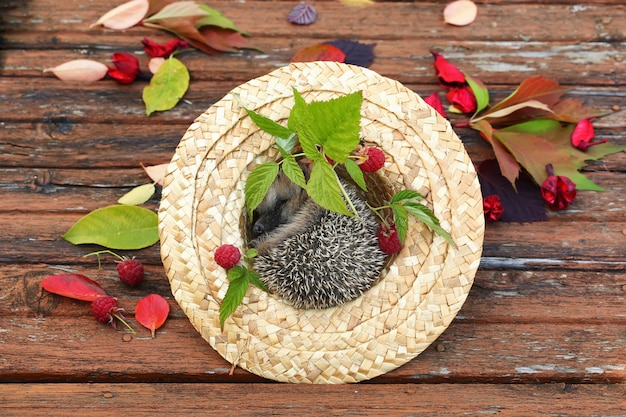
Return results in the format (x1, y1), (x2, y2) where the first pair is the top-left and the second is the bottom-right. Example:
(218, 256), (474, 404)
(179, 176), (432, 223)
(478, 159), (548, 223)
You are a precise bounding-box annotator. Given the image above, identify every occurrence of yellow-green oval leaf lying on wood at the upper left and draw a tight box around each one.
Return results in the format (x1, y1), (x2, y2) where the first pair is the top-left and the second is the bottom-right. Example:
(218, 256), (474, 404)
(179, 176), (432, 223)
(142, 56), (189, 116)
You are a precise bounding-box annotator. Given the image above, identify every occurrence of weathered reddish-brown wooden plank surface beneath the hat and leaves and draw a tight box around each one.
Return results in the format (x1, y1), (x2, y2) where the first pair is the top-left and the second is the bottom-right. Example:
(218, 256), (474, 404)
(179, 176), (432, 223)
(0, 0), (626, 416)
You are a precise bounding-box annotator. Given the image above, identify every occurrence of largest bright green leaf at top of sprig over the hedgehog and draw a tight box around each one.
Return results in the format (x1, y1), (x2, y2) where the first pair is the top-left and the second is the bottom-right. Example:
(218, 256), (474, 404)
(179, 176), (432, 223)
(297, 91), (363, 163)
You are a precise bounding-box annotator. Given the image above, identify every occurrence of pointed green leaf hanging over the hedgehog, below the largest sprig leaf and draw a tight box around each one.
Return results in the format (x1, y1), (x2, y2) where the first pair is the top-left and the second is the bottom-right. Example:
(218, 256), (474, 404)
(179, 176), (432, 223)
(306, 158), (352, 216)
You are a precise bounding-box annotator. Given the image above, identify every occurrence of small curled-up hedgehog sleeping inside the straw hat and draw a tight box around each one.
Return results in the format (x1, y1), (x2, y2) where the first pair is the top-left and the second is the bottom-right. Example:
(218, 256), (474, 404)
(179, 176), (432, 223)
(250, 164), (386, 309)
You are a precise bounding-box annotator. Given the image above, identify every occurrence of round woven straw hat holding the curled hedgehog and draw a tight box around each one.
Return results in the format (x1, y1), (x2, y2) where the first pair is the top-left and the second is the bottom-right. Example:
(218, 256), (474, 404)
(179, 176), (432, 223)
(159, 62), (484, 383)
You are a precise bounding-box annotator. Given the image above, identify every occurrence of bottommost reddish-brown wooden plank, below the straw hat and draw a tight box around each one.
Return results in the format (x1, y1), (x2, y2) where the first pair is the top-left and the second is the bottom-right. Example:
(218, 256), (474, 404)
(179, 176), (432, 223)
(0, 383), (625, 417)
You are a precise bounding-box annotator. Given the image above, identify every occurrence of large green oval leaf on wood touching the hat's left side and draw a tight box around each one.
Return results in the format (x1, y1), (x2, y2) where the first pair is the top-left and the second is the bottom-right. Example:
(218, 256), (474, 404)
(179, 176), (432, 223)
(63, 205), (159, 250)
